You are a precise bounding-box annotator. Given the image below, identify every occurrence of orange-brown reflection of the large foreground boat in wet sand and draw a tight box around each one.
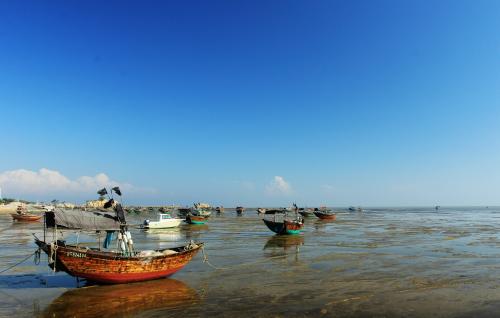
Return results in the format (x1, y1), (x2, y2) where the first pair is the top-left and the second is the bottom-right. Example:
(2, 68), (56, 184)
(41, 279), (199, 317)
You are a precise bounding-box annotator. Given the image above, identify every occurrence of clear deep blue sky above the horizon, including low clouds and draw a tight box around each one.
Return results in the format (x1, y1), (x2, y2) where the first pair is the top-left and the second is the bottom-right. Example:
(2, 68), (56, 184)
(0, 1), (500, 206)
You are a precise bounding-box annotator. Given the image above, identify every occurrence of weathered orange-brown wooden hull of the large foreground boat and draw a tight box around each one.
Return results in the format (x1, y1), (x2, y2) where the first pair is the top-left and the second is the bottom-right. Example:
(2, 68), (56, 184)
(35, 239), (203, 284)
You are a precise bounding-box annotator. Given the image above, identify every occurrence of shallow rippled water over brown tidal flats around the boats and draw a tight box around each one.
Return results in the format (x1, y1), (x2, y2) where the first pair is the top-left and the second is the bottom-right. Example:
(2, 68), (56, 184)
(0, 207), (500, 317)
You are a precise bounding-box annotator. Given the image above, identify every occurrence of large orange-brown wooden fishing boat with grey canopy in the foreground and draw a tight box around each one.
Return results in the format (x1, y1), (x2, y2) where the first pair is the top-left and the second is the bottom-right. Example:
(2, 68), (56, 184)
(35, 187), (203, 284)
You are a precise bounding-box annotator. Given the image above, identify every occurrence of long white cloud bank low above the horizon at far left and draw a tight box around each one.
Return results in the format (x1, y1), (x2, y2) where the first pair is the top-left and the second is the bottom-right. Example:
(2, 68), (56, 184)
(0, 168), (148, 199)
